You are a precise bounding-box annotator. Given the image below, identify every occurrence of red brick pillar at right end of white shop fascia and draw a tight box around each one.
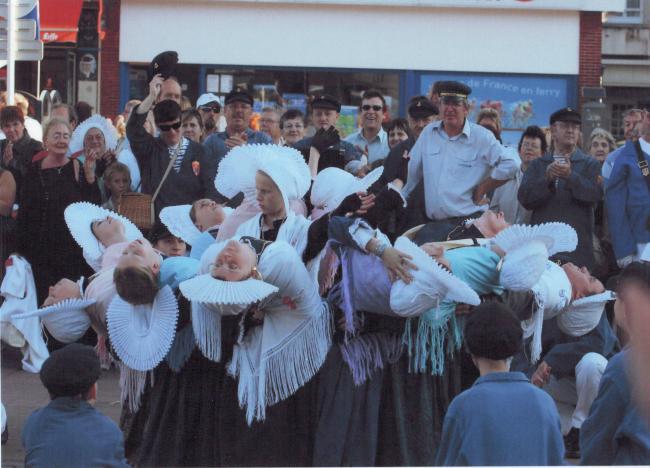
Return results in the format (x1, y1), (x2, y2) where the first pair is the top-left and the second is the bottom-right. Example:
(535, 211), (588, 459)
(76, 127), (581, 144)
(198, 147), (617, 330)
(578, 11), (603, 104)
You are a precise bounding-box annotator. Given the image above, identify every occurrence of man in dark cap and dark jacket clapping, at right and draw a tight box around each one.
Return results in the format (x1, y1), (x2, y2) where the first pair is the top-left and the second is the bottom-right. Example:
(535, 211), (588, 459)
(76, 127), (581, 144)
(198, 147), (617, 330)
(517, 107), (603, 270)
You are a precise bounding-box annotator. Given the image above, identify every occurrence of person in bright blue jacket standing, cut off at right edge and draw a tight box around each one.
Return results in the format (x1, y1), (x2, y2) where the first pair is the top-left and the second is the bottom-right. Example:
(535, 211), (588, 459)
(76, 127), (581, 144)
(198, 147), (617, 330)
(605, 132), (650, 267)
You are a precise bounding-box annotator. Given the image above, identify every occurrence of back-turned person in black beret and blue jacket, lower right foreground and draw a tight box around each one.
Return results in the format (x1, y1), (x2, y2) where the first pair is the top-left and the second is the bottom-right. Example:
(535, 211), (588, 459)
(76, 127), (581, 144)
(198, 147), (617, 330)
(436, 302), (564, 466)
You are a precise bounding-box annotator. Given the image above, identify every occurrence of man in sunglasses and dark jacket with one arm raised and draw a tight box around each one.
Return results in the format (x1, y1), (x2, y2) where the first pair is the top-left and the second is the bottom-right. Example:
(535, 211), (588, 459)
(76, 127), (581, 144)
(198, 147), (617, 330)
(126, 74), (219, 216)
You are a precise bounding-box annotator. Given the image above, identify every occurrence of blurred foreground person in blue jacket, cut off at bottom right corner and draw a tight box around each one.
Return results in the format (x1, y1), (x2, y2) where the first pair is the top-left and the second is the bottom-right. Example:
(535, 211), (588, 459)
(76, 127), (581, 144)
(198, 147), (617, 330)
(580, 262), (650, 465)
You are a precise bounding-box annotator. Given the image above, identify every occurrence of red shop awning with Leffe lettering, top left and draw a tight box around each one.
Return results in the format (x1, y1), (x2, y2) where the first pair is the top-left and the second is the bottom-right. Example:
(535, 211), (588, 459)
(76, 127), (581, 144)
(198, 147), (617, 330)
(39, 0), (83, 43)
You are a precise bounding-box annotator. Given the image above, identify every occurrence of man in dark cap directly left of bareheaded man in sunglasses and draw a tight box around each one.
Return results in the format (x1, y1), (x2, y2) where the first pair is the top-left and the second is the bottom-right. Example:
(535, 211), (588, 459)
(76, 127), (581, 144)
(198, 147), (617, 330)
(294, 94), (362, 176)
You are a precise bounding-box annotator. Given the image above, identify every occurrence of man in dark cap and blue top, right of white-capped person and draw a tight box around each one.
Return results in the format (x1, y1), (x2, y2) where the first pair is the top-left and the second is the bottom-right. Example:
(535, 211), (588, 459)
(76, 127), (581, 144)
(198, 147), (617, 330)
(203, 87), (272, 167)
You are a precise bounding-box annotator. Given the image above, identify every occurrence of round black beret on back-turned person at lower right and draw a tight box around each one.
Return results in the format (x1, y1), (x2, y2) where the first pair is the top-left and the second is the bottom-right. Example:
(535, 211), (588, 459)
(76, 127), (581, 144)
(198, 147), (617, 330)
(465, 301), (523, 361)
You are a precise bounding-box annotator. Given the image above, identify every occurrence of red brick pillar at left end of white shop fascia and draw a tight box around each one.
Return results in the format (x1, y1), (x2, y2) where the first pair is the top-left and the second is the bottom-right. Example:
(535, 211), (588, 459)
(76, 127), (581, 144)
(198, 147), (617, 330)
(99, 0), (121, 118)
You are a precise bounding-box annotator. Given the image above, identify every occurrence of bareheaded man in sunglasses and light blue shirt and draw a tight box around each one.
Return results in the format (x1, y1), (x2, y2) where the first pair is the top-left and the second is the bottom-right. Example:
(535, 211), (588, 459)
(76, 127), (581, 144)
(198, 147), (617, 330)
(345, 89), (390, 164)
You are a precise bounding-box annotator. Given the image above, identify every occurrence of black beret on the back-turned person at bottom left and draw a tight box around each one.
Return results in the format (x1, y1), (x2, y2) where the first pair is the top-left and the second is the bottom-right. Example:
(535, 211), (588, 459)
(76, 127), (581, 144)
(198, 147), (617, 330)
(40, 343), (101, 399)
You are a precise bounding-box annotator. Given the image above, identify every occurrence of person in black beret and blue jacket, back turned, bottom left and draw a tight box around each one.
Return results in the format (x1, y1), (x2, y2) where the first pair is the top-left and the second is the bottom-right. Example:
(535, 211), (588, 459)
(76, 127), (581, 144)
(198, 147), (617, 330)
(22, 343), (128, 466)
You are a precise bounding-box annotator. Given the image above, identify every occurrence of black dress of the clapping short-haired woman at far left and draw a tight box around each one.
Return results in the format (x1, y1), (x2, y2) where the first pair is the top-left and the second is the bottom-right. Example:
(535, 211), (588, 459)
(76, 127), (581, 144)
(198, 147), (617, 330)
(17, 157), (101, 304)
